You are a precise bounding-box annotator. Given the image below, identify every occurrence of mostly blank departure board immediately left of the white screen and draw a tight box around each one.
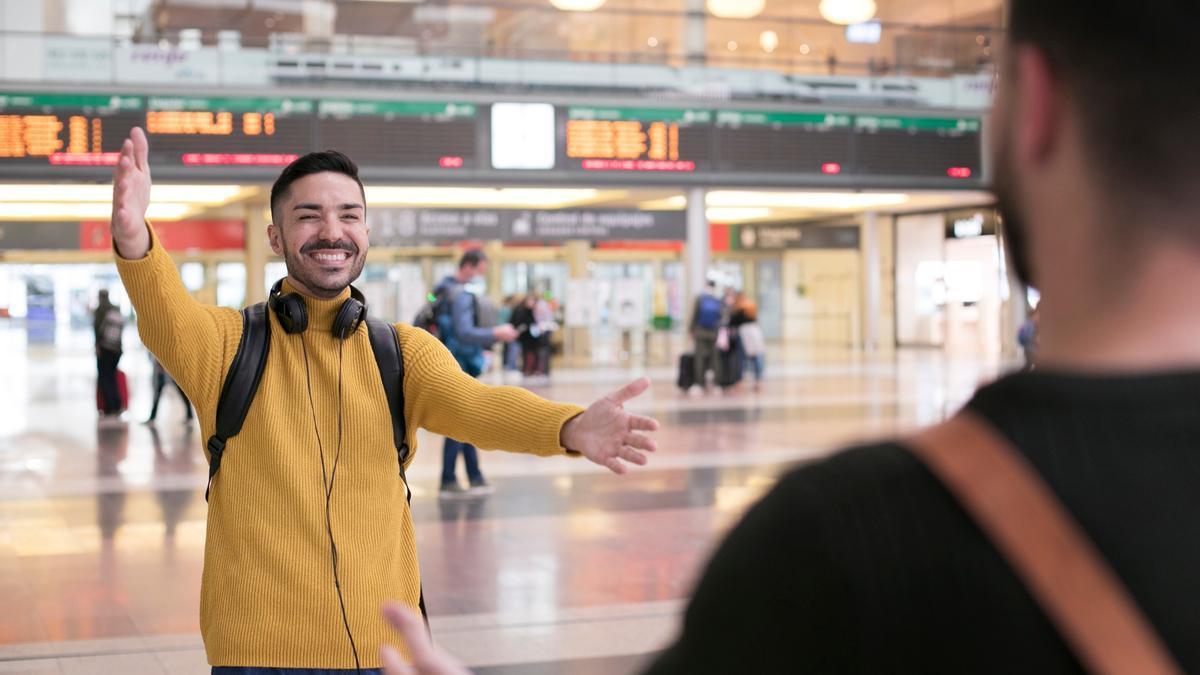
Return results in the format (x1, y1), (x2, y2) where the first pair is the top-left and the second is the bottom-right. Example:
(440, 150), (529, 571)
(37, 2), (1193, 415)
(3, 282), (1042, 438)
(317, 100), (481, 169)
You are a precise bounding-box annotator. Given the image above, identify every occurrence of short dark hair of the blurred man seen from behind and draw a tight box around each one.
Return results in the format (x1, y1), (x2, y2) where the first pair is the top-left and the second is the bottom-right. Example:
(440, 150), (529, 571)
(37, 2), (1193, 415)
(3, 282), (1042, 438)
(1009, 0), (1200, 209)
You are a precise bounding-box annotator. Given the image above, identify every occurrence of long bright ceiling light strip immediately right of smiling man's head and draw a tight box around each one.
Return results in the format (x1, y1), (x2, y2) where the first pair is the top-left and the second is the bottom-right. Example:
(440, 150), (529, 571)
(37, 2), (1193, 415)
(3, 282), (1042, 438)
(366, 186), (599, 207)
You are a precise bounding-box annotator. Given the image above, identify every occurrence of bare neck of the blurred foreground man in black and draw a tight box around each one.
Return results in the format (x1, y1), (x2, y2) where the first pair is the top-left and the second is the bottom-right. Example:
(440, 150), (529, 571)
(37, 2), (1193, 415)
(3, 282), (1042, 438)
(1038, 245), (1200, 372)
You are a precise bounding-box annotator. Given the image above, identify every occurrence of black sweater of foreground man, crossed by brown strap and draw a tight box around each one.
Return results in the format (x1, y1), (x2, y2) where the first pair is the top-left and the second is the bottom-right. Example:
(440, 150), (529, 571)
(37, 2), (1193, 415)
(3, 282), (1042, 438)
(649, 372), (1200, 675)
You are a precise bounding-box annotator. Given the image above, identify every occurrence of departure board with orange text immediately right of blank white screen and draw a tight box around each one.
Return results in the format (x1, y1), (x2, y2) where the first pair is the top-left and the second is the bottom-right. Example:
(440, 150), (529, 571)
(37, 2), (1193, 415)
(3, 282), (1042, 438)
(559, 106), (713, 173)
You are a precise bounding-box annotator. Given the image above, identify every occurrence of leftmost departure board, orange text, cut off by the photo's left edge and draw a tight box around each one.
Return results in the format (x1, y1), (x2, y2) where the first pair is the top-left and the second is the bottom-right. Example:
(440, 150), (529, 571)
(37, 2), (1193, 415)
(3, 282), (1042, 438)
(0, 94), (144, 166)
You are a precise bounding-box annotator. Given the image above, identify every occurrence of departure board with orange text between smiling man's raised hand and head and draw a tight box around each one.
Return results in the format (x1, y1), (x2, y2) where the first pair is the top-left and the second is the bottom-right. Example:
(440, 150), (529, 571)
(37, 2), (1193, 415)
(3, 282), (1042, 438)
(144, 96), (316, 166)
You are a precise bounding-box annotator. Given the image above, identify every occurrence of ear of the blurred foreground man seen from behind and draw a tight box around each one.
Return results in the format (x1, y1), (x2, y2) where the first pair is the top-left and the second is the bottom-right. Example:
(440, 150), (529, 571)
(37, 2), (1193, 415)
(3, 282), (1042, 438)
(1013, 46), (1066, 165)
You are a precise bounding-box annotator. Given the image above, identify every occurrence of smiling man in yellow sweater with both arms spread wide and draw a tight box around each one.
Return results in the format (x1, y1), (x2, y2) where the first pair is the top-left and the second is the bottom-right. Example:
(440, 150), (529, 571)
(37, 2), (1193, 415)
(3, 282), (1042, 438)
(112, 129), (658, 674)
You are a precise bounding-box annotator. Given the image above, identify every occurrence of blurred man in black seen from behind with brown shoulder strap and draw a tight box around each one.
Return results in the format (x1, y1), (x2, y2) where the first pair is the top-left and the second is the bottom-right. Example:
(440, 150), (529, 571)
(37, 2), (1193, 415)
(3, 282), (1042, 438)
(372, 0), (1200, 675)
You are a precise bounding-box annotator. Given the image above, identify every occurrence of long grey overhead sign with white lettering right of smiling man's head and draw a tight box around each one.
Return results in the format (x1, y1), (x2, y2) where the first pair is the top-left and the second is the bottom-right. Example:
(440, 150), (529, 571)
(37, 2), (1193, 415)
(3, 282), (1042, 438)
(367, 208), (688, 246)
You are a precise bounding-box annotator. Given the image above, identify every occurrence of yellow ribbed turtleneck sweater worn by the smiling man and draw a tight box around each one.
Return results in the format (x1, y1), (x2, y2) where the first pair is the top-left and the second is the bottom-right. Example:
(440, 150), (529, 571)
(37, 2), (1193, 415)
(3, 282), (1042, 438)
(118, 224), (582, 668)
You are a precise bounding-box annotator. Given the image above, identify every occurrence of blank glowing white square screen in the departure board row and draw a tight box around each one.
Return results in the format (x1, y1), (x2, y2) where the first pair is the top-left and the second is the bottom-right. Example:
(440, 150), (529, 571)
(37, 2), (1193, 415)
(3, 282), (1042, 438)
(492, 103), (554, 171)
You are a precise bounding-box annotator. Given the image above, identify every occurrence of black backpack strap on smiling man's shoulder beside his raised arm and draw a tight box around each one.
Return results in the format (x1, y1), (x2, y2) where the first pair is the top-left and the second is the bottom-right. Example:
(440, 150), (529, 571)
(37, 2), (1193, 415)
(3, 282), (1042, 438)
(204, 303), (271, 501)
